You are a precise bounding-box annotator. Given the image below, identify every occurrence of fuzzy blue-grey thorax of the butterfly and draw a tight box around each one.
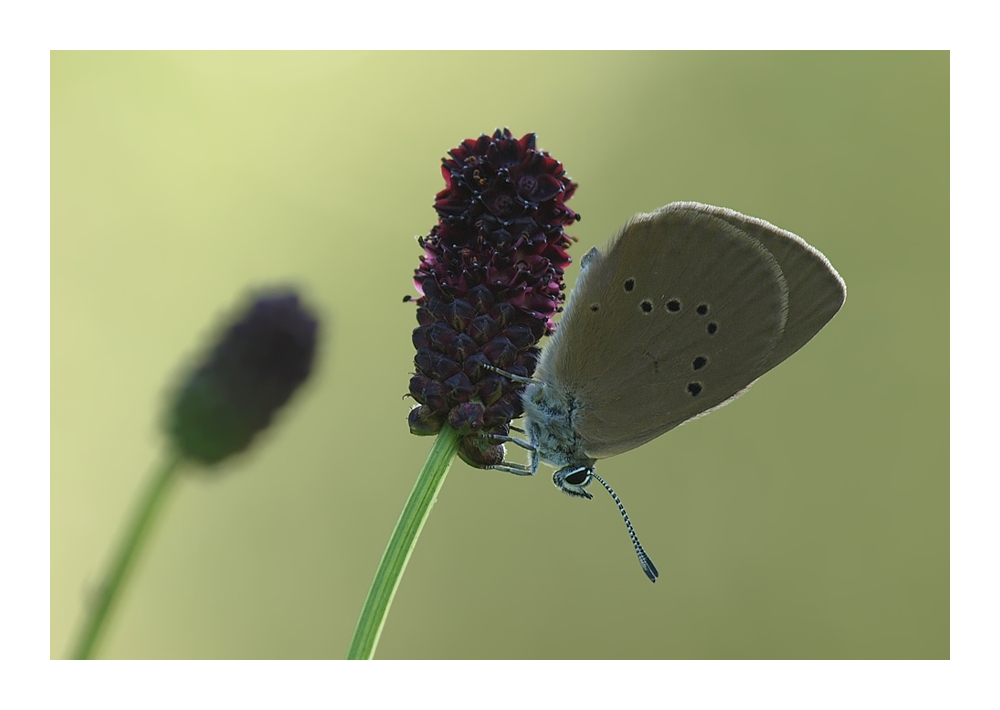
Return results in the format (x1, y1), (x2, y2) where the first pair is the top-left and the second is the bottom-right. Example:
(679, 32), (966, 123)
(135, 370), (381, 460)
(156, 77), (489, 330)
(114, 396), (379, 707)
(522, 382), (594, 468)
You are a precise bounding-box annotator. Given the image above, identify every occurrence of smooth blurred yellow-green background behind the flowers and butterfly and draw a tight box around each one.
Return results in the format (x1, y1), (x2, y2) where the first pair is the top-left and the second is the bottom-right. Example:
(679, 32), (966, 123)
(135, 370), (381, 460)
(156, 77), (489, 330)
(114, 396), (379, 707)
(51, 52), (949, 658)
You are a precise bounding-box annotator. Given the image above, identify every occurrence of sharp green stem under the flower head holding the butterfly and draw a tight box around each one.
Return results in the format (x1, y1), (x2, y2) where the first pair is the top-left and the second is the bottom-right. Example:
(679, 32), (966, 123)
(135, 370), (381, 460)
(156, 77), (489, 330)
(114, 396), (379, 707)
(347, 425), (459, 660)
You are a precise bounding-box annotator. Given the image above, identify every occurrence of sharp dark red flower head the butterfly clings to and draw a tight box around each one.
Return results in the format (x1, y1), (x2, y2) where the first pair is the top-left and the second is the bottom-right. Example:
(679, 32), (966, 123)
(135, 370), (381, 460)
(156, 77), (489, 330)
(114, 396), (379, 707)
(410, 129), (580, 466)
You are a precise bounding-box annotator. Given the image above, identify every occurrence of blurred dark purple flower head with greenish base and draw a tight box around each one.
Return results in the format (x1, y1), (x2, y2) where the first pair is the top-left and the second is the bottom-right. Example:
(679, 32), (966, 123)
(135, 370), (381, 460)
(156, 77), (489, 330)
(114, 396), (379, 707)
(166, 290), (319, 465)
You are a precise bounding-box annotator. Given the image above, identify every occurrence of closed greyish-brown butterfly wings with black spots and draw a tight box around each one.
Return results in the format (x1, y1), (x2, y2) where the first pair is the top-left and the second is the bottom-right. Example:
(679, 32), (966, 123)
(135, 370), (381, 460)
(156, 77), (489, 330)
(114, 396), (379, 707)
(539, 203), (843, 458)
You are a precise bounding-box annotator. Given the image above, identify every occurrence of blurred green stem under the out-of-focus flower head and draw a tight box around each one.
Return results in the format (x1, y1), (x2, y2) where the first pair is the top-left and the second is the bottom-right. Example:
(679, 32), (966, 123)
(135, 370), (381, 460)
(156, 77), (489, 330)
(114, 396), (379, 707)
(73, 452), (182, 659)
